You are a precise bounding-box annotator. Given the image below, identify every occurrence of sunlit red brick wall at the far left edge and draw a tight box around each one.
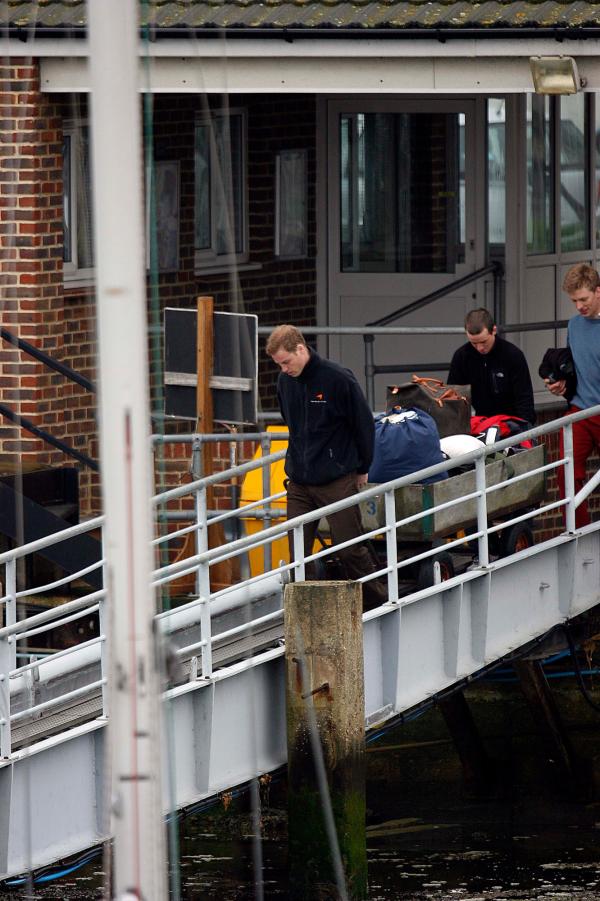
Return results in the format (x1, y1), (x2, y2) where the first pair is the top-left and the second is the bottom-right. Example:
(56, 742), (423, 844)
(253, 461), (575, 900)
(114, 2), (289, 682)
(0, 61), (64, 463)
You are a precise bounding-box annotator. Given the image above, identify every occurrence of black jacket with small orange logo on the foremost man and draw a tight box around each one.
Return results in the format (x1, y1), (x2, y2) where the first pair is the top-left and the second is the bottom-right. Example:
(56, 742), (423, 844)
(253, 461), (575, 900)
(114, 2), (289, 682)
(277, 350), (375, 485)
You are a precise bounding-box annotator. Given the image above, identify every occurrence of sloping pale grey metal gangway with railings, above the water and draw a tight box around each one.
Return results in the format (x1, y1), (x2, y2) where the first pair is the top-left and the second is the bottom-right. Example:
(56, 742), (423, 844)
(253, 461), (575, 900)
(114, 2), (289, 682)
(0, 407), (600, 878)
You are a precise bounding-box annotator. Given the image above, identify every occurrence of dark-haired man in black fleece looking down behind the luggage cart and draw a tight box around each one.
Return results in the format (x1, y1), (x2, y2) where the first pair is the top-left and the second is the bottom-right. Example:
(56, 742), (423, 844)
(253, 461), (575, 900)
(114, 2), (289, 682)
(448, 308), (535, 425)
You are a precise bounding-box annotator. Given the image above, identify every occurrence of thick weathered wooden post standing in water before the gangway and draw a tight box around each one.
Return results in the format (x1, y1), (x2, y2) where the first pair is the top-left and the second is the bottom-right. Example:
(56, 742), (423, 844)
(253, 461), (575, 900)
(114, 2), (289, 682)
(284, 582), (367, 899)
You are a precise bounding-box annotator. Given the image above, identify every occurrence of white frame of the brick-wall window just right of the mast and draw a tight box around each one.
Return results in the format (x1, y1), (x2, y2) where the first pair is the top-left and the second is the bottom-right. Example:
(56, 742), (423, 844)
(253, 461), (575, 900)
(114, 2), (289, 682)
(194, 108), (249, 272)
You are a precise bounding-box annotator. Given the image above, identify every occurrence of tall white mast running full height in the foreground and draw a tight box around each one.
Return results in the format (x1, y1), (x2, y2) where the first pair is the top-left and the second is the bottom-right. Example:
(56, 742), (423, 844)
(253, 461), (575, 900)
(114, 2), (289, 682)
(87, 0), (168, 901)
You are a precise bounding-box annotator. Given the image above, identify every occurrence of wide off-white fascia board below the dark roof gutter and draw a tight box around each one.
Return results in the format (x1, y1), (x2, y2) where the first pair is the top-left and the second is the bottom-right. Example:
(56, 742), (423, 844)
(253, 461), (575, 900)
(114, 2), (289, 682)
(41, 51), (600, 95)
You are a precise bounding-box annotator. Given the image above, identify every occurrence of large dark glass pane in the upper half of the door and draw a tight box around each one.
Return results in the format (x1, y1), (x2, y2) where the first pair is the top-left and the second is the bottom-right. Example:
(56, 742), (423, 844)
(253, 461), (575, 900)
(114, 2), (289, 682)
(340, 113), (464, 272)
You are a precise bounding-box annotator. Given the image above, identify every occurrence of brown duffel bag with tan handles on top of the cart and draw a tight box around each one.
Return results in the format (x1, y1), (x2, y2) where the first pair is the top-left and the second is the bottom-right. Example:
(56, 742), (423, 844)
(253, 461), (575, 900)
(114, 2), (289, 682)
(386, 374), (471, 438)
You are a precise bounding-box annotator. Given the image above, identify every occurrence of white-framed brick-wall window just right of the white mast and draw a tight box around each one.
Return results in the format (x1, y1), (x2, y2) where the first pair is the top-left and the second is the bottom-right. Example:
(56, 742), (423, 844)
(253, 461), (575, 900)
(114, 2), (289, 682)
(194, 110), (248, 267)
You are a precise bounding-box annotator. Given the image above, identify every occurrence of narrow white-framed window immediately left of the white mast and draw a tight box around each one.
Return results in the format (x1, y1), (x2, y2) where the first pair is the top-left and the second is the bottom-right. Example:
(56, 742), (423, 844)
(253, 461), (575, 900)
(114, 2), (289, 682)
(63, 124), (94, 281)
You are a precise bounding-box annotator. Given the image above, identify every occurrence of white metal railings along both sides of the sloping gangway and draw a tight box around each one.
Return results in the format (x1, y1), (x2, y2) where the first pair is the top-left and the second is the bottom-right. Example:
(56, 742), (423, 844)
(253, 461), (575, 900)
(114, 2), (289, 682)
(0, 407), (600, 759)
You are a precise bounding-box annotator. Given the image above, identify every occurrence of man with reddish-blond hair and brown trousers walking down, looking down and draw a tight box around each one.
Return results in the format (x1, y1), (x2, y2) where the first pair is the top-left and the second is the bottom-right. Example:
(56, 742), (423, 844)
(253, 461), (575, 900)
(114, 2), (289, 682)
(267, 325), (387, 609)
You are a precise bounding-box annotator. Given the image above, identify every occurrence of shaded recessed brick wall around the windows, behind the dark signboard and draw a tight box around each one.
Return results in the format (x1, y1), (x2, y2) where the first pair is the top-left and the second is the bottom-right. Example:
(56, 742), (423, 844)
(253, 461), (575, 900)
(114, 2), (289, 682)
(52, 95), (316, 513)
